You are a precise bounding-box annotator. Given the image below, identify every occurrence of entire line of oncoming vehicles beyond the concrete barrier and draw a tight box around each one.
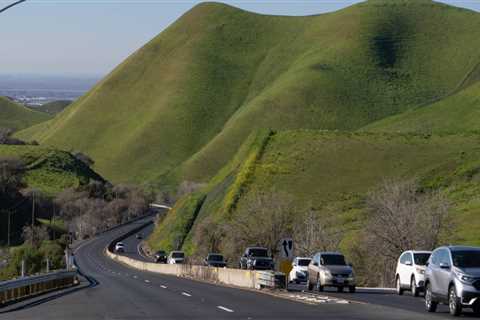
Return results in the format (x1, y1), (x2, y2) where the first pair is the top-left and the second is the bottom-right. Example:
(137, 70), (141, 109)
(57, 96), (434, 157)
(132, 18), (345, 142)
(115, 242), (480, 316)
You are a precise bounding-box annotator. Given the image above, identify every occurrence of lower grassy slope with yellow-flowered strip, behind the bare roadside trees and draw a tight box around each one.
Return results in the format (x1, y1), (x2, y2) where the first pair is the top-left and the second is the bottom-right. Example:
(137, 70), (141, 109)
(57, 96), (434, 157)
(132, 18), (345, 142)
(149, 130), (480, 253)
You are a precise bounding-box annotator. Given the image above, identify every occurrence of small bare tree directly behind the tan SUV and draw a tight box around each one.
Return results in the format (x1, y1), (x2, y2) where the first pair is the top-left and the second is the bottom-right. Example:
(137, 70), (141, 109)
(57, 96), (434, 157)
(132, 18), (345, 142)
(294, 209), (342, 256)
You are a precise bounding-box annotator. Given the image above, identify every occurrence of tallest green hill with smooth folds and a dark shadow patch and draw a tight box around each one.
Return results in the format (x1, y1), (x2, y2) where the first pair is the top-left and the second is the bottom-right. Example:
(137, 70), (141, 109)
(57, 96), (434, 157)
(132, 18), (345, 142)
(16, 0), (480, 185)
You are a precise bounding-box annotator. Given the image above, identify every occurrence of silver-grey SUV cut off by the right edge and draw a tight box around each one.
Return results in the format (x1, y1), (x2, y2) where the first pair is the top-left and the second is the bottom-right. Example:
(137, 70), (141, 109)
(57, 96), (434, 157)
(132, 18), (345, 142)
(425, 246), (480, 316)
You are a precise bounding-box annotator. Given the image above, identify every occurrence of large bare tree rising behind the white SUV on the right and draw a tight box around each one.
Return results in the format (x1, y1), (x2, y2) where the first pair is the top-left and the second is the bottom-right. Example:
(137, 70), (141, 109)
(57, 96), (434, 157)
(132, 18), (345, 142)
(365, 180), (450, 285)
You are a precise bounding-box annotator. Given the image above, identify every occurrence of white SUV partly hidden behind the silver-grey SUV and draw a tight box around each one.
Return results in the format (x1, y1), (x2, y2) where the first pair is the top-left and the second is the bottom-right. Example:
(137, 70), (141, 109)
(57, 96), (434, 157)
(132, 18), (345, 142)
(395, 250), (432, 297)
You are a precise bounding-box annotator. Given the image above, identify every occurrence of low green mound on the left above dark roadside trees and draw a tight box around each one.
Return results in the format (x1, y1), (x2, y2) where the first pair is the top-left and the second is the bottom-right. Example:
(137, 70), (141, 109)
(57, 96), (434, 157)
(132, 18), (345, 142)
(0, 145), (104, 195)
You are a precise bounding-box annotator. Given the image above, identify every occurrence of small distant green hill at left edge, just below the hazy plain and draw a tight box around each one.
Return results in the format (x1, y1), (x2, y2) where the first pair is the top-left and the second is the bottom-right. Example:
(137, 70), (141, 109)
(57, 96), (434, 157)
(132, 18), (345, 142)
(0, 97), (51, 130)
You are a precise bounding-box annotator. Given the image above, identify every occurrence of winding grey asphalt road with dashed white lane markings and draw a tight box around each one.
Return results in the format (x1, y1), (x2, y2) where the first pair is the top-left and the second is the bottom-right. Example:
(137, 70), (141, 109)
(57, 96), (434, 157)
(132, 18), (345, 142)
(0, 221), (468, 320)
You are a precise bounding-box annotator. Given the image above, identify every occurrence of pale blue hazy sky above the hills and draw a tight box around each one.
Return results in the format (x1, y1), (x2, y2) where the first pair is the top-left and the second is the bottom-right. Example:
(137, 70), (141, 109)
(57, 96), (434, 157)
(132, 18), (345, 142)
(0, 0), (480, 75)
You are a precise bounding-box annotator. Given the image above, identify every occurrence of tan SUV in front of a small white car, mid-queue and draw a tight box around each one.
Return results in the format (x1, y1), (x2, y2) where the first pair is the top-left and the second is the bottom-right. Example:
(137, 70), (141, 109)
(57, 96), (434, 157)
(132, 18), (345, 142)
(307, 252), (356, 293)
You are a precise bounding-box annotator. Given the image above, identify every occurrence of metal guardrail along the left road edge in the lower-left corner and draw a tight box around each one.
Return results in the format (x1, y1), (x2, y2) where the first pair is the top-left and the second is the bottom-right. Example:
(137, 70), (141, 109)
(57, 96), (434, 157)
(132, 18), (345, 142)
(0, 270), (78, 306)
